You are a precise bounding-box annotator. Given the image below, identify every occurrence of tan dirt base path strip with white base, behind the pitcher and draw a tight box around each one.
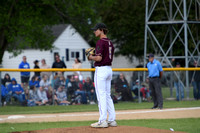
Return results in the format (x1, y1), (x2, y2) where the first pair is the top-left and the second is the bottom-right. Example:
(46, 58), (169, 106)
(0, 107), (200, 123)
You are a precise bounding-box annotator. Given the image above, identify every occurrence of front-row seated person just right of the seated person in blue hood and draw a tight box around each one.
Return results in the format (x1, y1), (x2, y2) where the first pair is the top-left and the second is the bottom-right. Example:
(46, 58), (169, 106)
(27, 85), (42, 106)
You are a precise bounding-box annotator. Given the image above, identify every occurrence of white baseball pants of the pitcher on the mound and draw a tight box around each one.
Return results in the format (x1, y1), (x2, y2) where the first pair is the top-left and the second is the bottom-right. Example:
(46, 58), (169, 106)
(94, 66), (116, 123)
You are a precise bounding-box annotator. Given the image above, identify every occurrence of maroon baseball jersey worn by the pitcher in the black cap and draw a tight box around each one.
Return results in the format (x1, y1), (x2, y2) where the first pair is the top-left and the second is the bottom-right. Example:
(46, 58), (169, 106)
(94, 38), (114, 66)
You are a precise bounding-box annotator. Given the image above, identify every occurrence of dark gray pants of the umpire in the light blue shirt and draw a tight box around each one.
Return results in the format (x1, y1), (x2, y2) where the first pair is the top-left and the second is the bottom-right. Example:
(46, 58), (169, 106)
(149, 78), (163, 108)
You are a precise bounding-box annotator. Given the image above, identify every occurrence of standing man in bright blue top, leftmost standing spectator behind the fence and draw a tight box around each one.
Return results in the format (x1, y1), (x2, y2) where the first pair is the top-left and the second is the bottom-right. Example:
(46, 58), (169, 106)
(19, 56), (30, 87)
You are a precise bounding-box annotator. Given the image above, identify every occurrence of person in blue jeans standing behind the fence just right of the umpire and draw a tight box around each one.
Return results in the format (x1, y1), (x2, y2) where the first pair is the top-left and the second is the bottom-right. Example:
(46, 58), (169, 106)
(174, 62), (185, 101)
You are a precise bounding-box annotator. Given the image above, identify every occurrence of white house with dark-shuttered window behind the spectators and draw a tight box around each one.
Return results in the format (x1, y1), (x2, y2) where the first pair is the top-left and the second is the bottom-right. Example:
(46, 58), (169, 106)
(2, 25), (139, 82)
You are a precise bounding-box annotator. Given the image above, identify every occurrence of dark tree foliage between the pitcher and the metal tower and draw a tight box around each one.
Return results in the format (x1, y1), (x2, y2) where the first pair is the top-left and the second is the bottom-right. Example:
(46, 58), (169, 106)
(100, 0), (145, 59)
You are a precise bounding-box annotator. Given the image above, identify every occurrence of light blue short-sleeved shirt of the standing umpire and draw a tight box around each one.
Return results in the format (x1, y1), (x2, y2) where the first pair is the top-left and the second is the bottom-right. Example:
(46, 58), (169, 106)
(147, 59), (163, 77)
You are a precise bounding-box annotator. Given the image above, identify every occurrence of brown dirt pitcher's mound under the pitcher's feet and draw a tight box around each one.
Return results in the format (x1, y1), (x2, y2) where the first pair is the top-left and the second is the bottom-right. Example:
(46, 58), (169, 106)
(13, 126), (184, 133)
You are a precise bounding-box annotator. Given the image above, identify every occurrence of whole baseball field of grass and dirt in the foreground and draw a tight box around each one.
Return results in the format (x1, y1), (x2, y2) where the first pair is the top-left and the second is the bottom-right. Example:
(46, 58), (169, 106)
(0, 101), (200, 133)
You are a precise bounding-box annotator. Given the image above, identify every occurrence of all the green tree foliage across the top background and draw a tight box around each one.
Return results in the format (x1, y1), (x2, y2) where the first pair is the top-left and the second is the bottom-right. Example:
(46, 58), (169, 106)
(0, 0), (197, 63)
